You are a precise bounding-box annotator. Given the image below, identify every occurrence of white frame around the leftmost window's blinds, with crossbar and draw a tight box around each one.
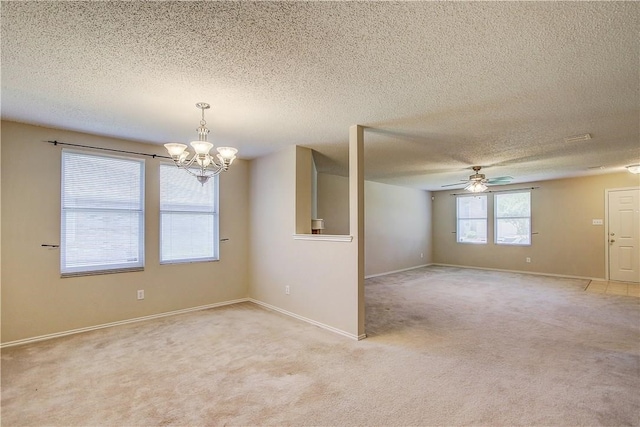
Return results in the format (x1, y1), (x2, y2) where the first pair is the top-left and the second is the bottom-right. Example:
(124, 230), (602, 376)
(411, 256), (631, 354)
(60, 149), (146, 277)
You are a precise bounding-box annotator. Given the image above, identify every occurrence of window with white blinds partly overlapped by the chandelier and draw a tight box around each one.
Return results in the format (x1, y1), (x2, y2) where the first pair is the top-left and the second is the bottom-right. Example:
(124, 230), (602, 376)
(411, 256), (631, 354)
(160, 165), (219, 264)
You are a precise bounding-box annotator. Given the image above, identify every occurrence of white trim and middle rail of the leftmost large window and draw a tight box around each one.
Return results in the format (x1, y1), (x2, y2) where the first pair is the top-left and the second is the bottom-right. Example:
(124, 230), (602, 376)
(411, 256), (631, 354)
(59, 148), (146, 278)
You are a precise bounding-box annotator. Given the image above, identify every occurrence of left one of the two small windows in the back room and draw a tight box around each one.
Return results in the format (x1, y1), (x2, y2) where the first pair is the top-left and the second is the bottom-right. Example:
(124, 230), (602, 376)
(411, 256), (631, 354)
(456, 195), (487, 243)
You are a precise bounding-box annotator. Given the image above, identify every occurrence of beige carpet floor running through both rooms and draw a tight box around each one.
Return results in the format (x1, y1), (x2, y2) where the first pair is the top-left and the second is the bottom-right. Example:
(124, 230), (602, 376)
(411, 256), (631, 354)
(0, 266), (640, 426)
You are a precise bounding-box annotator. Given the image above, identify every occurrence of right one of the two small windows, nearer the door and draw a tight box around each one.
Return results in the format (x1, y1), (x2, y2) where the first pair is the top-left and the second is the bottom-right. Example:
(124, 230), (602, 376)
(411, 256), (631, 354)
(495, 191), (531, 245)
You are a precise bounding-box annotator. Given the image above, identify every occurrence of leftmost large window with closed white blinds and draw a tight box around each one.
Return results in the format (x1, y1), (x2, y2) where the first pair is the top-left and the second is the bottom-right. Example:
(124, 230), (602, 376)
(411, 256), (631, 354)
(60, 150), (144, 276)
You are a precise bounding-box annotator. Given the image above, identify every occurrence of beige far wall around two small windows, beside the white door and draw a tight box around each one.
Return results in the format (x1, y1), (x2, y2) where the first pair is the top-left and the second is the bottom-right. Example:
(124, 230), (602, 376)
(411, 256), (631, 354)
(433, 172), (640, 279)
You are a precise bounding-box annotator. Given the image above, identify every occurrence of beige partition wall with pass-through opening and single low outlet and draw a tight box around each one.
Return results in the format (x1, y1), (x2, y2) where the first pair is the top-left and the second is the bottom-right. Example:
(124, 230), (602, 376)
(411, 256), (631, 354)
(250, 147), (362, 337)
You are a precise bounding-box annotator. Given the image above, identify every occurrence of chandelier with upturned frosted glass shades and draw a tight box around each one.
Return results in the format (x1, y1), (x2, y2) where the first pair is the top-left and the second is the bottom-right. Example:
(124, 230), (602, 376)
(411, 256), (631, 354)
(164, 102), (238, 185)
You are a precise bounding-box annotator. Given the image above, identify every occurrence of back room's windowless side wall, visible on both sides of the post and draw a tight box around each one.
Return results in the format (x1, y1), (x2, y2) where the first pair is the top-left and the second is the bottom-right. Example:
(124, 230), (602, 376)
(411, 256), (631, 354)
(318, 173), (431, 276)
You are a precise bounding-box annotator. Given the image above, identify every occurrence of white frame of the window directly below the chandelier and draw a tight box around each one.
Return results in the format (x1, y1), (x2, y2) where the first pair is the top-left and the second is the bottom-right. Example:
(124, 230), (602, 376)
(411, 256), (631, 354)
(158, 162), (220, 265)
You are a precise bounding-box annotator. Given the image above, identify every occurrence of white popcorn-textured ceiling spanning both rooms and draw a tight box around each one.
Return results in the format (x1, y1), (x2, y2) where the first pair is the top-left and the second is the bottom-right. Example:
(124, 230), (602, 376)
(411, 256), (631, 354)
(1, 1), (640, 190)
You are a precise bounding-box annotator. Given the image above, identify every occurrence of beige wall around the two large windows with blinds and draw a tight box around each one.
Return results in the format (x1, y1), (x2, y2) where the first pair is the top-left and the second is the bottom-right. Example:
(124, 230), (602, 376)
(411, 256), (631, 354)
(1, 122), (249, 343)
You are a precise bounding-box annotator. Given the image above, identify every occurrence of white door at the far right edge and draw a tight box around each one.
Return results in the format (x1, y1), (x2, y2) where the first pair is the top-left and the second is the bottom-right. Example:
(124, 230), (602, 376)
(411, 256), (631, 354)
(607, 189), (640, 282)
